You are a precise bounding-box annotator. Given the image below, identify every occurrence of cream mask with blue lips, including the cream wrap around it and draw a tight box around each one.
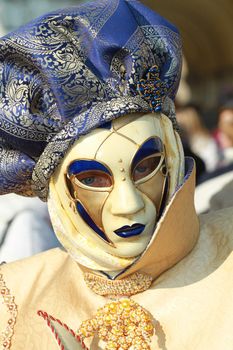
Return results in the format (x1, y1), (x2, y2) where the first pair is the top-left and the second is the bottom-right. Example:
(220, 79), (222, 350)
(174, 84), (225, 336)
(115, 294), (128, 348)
(48, 113), (182, 271)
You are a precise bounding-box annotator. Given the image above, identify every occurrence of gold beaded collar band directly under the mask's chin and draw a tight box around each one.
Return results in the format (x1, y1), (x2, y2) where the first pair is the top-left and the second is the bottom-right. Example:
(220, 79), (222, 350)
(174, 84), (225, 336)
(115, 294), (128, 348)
(84, 272), (152, 296)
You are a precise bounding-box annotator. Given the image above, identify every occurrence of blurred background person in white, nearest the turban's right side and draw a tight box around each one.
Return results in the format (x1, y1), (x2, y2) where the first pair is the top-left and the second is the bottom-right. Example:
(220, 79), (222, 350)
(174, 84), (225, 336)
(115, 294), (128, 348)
(177, 104), (222, 172)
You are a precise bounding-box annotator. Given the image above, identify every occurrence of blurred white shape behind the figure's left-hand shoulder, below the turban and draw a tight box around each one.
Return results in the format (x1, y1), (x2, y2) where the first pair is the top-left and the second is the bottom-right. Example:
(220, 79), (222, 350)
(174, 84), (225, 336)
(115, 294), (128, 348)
(0, 194), (59, 262)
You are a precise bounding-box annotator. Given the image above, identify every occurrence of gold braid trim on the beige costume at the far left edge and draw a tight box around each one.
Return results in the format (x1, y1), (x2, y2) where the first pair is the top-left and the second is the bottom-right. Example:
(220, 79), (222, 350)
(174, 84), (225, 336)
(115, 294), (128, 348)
(0, 274), (17, 350)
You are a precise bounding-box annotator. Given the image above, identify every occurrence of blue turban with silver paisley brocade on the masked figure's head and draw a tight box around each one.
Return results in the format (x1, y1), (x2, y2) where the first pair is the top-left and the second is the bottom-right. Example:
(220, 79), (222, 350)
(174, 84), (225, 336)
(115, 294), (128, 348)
(0, 0), (181, 200)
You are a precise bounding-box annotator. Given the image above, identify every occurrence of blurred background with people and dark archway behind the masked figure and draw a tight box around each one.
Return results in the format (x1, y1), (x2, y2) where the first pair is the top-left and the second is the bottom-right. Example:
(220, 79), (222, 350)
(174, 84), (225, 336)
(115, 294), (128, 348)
(0, 0), (233, 262)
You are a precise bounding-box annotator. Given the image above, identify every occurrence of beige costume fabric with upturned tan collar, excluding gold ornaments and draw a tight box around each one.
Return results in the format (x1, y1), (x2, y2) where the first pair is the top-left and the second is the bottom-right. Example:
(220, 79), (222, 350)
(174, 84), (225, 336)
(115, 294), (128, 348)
(0, 167), (233, 350)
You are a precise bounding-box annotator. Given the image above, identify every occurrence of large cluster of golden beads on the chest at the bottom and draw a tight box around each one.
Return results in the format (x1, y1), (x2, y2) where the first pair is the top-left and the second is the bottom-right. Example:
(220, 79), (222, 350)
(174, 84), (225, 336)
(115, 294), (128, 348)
(78, 298), (154, 350)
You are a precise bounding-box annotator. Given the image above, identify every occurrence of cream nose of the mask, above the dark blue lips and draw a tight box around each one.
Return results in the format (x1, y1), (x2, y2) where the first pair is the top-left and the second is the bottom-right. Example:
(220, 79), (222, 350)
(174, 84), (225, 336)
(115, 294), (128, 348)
(109, 181), (145, 215)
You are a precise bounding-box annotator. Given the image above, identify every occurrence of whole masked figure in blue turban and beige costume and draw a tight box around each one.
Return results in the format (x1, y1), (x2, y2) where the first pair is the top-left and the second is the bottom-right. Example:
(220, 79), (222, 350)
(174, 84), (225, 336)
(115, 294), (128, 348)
(0, 0), (233, 350)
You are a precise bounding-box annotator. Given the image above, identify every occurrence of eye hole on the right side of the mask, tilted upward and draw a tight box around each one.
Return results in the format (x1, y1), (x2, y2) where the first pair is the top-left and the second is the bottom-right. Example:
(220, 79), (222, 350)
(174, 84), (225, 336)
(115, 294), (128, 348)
(132, 154), (163, 182)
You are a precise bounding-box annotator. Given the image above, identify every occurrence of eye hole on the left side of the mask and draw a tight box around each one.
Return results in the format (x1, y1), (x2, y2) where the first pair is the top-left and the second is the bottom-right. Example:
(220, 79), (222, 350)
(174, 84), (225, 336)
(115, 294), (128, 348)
(71, 171), (112, 188)
